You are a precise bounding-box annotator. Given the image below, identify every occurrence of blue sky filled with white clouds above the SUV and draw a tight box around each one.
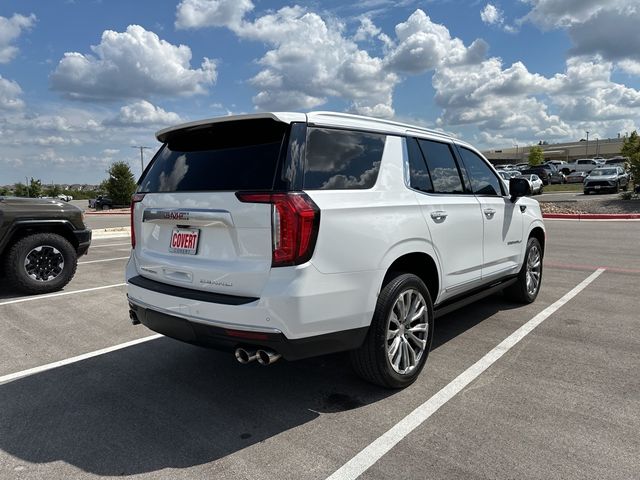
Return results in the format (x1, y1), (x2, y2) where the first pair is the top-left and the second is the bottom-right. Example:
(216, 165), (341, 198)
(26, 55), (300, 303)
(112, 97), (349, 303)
(0, 0), (640, 185)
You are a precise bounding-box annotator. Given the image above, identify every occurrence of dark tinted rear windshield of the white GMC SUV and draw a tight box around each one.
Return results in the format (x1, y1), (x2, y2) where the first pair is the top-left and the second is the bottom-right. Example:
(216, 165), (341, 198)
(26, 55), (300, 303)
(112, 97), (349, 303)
(138, 119), (288, 193)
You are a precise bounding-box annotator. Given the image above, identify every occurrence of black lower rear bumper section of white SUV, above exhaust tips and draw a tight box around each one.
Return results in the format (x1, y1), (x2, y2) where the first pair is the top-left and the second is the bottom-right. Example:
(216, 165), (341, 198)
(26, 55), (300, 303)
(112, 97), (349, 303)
(129, 298), (368, 360)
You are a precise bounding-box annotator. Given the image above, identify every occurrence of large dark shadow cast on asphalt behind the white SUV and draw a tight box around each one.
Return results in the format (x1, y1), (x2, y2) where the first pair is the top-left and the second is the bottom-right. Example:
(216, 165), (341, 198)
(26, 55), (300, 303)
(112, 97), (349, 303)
(0, 338), (394, 476)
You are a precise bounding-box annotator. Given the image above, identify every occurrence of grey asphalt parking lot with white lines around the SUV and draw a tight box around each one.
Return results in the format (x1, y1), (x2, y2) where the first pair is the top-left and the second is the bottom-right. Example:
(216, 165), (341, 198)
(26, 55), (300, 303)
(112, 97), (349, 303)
(0, 217), (640, 480)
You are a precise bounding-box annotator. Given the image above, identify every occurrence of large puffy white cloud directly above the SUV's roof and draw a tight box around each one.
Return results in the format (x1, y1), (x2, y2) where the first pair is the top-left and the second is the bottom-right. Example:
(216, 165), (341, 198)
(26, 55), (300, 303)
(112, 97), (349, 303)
(240, 7), (399, 116)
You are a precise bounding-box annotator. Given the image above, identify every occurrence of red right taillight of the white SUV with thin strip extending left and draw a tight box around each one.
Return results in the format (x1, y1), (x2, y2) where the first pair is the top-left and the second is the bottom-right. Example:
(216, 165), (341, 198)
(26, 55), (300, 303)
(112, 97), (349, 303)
(236, 192), (320, 267)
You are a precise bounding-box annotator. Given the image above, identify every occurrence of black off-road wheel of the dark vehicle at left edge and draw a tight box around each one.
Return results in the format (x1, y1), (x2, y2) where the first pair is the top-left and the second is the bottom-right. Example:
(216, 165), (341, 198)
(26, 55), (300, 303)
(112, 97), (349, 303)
(4, 233), (78, 294)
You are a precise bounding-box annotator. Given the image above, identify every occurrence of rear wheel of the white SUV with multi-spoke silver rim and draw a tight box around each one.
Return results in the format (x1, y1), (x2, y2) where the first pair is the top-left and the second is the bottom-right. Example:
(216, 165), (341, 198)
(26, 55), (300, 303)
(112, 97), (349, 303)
(351, 273), (433, 388)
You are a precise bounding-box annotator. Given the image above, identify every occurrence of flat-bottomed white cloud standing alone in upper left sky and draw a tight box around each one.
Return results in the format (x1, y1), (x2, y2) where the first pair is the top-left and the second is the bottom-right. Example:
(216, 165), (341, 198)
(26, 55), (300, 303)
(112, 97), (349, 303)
(50, 25), (217, 100)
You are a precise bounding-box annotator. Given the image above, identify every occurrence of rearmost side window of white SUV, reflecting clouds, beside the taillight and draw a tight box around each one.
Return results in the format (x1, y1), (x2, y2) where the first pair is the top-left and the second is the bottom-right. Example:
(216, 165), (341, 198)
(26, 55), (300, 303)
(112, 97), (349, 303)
(304, 128), (386, 190)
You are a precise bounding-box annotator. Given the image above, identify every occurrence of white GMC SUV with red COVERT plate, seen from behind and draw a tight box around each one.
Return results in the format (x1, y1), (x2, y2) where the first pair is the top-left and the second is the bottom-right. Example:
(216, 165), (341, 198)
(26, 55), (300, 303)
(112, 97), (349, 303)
(126, 112), (545, 388)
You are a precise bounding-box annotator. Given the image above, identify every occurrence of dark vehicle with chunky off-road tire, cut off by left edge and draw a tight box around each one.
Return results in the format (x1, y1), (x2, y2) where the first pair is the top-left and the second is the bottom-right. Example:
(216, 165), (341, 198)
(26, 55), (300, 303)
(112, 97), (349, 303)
(0, 197), (91, 293)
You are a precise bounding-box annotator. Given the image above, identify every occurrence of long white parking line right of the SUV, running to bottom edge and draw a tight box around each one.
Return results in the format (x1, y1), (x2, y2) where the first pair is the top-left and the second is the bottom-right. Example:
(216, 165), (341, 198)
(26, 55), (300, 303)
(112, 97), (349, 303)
(327, 268), (605, 480)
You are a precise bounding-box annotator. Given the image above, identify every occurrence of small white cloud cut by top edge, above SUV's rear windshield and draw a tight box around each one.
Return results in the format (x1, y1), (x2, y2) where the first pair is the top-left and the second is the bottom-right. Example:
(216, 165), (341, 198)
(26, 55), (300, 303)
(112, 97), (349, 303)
(175, 0), (253, 29)
